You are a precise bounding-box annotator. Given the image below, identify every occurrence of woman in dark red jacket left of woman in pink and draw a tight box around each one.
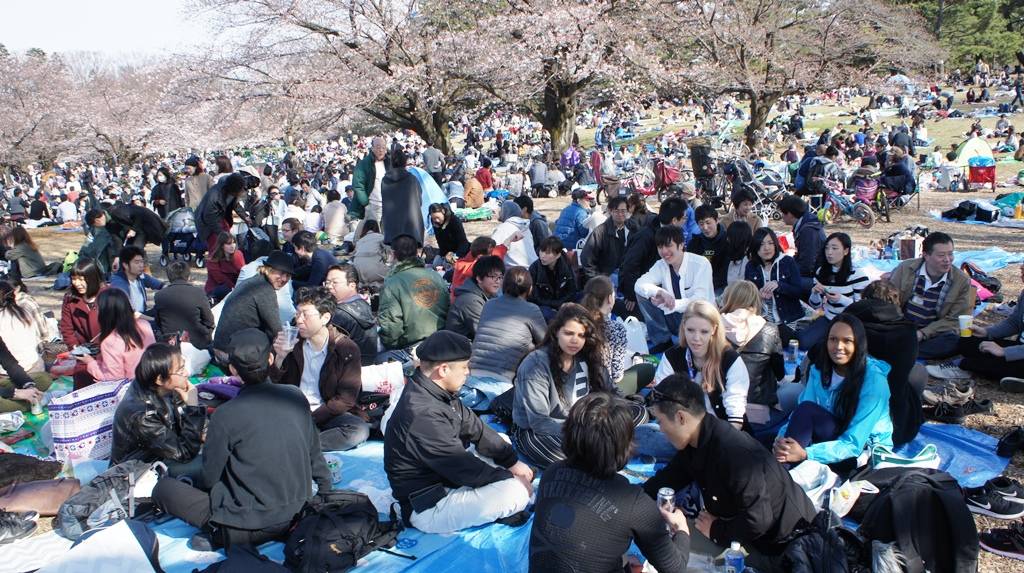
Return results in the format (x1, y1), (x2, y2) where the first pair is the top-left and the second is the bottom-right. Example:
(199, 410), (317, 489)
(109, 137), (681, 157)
(59, 257), (108, 388)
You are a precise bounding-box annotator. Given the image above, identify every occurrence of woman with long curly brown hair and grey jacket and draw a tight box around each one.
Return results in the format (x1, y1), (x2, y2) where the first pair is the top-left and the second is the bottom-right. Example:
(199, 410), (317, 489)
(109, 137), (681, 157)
(511, 303), (647, 469)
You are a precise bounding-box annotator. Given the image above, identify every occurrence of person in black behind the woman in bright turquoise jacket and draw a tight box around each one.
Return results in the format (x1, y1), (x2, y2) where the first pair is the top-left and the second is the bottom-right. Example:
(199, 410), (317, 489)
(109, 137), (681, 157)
(843, 280), (928, 446)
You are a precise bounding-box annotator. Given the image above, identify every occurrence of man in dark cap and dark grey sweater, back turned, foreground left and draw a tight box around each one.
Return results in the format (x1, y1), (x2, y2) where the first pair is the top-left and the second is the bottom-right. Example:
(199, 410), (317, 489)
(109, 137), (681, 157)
(153, 328), (332, 549)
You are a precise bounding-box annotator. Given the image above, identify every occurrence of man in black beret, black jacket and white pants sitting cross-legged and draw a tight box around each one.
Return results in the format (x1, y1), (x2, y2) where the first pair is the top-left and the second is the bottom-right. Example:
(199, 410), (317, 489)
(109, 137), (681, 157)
(384, 330), (534, 533)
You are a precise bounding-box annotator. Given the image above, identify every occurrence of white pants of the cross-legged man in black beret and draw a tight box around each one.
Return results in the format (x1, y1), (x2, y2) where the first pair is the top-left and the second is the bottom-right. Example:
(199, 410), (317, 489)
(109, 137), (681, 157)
(410, 478), (529, 533)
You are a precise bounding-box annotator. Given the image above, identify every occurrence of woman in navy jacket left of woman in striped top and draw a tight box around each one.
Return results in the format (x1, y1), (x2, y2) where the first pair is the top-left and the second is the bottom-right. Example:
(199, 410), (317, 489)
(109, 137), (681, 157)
(743, 227), (804, 343)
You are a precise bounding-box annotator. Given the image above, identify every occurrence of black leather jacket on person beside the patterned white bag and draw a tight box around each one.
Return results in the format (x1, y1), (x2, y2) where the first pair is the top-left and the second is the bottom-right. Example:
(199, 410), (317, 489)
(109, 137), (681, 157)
(111, 382), (206, 466)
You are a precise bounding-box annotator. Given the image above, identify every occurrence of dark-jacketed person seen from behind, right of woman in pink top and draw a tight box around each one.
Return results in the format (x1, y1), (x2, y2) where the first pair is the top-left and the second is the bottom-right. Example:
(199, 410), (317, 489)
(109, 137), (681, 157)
(152, 261), (216, 349)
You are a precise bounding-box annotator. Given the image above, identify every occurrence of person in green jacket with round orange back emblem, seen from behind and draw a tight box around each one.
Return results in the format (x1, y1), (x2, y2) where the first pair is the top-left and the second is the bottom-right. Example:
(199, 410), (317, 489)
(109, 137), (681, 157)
(378, 234), (449, 362)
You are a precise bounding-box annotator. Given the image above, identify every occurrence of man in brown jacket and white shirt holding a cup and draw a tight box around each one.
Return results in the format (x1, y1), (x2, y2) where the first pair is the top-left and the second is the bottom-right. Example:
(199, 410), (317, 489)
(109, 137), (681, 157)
(270, 287), (370, 450)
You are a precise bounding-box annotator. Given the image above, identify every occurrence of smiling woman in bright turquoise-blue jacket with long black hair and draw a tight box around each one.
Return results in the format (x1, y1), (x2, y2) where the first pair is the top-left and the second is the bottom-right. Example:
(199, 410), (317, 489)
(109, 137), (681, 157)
(774, 314), (893, 466)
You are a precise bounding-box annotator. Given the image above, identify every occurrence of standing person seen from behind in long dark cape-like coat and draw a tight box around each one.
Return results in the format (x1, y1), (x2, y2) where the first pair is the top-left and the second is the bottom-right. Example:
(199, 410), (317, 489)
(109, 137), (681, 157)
(381, 147), (426, 247)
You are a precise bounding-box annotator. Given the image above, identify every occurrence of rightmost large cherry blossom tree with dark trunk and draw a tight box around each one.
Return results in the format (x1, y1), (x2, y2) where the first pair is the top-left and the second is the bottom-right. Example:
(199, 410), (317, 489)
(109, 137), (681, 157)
(628, 0), (941, 146)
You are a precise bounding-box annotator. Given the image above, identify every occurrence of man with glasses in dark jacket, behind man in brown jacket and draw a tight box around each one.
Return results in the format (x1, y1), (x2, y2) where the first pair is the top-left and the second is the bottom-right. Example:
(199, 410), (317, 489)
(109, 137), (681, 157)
(324, 265), (380, 366)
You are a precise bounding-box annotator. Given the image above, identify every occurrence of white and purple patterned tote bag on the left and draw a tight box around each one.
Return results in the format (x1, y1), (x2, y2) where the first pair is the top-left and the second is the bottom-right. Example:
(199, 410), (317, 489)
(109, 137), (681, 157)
(49, 380), (131, 461)
